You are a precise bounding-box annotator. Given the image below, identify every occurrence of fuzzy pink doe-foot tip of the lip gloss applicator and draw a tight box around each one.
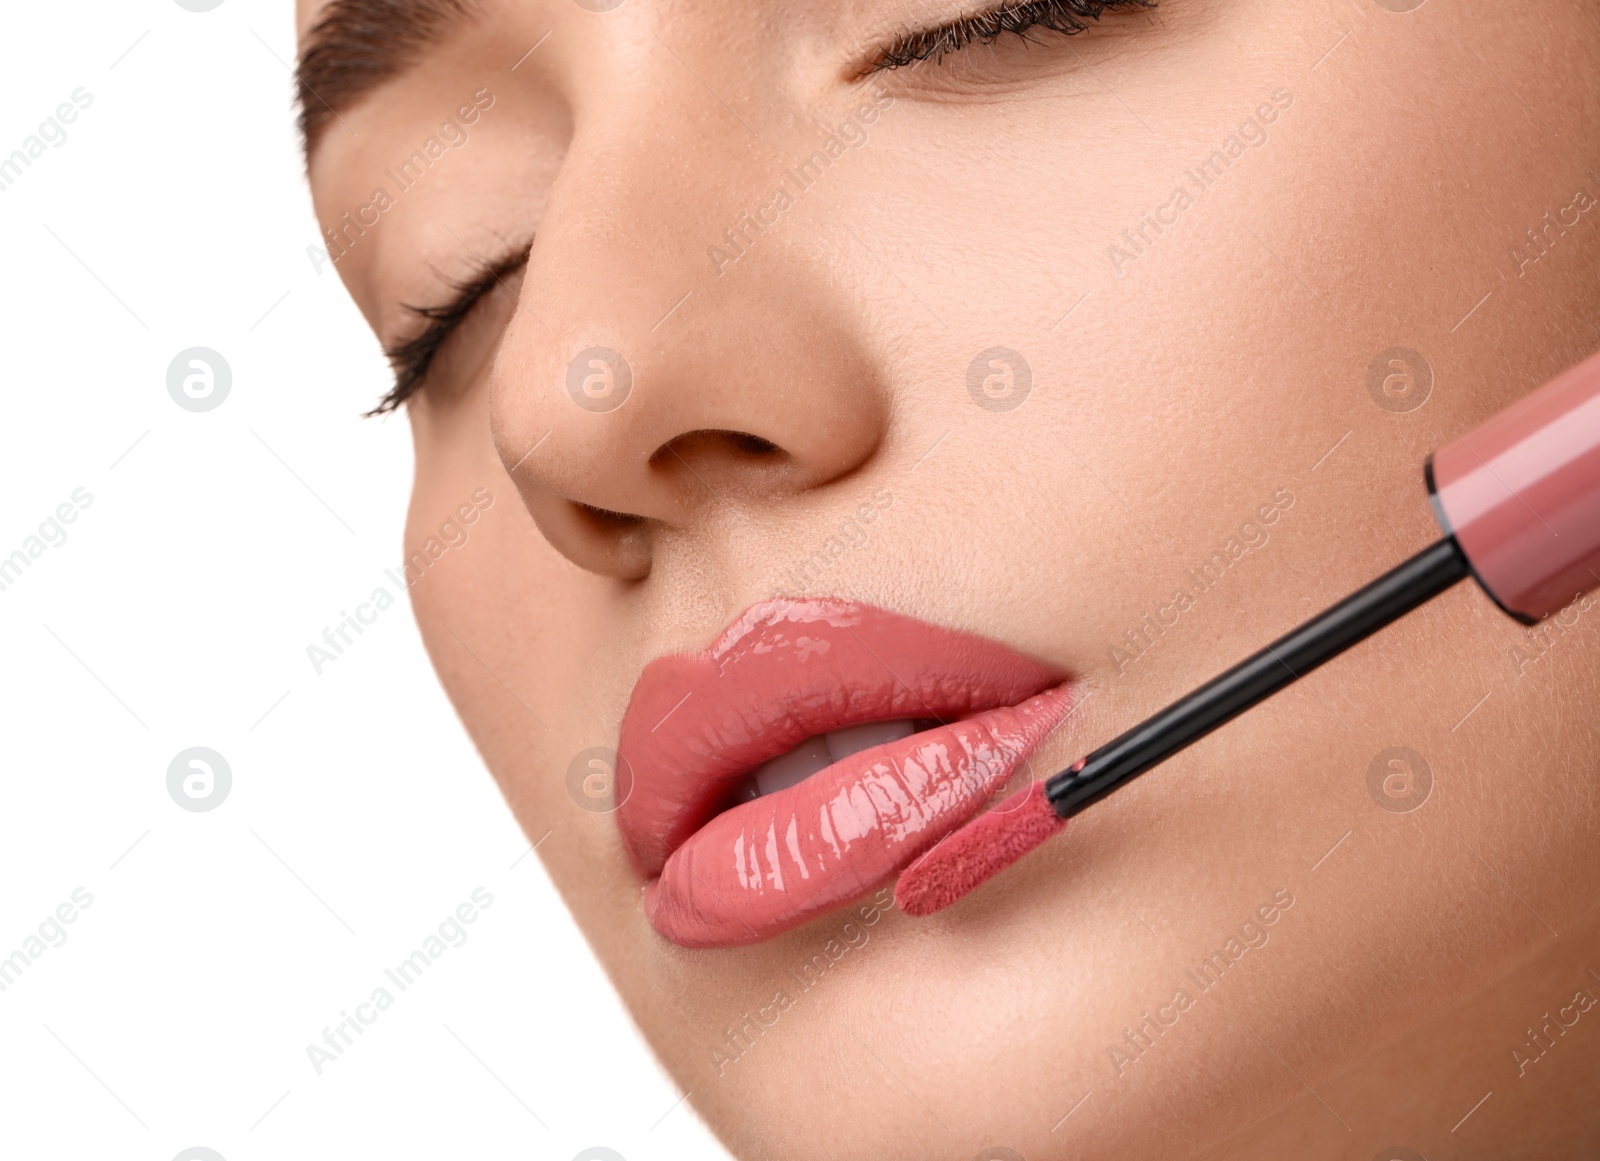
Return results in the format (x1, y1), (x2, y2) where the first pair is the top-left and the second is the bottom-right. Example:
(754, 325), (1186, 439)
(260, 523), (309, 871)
(894, 782), (1067, 918)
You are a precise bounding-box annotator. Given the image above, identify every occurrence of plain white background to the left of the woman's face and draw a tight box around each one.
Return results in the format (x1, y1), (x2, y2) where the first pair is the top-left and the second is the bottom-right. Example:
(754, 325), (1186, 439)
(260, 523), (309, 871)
(0, 0), (725, 1161)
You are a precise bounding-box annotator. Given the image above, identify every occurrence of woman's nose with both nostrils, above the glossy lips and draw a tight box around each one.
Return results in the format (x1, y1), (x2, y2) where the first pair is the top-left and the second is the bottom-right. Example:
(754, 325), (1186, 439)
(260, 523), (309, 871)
(490, 48), (890, 579)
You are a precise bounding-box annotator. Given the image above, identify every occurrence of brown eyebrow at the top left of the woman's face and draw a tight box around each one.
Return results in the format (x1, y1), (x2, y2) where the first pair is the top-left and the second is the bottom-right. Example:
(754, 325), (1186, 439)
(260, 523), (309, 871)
(294, 0), (477, 155)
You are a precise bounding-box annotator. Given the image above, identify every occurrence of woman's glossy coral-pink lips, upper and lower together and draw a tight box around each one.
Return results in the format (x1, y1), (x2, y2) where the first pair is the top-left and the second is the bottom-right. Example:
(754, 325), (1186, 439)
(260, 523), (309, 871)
(616, 598), (1072, 947)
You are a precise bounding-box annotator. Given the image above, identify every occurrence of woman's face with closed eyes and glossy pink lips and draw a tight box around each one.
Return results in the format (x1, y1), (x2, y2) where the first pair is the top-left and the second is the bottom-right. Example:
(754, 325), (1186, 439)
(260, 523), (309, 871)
(299, 0), (1600, 1161)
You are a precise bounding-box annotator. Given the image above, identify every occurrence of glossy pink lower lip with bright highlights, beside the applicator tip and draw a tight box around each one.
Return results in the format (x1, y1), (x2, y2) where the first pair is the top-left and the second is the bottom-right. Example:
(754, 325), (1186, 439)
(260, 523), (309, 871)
(645, 686), (1072, 947)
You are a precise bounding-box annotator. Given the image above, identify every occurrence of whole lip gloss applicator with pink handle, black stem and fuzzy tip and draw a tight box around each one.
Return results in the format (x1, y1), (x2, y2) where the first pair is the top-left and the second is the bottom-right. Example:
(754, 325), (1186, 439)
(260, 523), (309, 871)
(894, 355), (1600, 915)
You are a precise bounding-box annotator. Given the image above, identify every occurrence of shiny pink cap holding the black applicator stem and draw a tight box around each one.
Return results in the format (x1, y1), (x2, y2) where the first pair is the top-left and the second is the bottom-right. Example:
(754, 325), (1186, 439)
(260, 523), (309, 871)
(1427, 355), (1600, 622)
